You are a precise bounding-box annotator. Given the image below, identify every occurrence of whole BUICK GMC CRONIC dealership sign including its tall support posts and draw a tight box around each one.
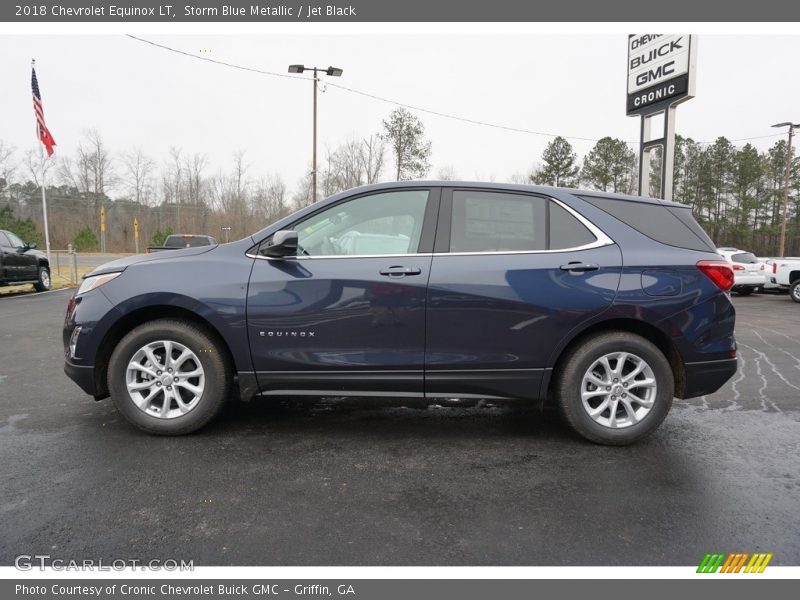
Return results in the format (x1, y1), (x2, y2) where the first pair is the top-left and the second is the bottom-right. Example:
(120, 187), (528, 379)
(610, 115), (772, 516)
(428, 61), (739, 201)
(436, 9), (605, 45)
(625, 33), (697, 200)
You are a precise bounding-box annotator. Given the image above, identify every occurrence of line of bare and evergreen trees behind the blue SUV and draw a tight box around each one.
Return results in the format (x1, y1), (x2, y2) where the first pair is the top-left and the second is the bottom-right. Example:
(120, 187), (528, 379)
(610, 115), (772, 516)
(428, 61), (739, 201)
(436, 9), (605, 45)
(0, 108), (800, 255)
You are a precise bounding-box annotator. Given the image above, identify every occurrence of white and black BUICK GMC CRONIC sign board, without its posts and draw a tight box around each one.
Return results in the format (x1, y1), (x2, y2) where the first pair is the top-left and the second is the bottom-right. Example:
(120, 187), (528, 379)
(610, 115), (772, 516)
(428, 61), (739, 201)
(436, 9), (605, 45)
(626, 33), (695, 115)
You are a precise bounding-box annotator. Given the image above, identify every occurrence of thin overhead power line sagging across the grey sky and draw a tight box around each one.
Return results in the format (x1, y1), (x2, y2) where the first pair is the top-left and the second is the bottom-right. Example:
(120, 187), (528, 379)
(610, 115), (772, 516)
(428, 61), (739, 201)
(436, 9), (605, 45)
(125, 33), (783, 146)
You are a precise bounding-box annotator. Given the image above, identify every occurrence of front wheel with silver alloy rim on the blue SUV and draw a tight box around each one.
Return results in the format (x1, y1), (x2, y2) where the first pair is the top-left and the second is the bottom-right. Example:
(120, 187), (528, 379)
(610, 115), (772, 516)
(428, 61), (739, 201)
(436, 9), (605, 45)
(108, 319), (233, 435)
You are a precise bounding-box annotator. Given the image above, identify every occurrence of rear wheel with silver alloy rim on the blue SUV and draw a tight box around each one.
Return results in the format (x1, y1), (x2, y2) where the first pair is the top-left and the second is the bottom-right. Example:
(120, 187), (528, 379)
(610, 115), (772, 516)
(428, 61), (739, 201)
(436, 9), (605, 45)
(554, 331), (674, 446)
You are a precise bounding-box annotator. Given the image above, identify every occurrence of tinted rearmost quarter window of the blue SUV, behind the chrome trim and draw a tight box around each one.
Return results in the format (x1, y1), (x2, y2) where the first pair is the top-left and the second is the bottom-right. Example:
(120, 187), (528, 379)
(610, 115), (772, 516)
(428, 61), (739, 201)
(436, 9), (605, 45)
(583, 196), (716, 252)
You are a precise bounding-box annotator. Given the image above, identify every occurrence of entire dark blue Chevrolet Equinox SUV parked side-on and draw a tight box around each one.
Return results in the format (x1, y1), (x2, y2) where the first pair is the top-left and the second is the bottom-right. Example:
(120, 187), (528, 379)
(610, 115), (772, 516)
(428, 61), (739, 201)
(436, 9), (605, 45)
(64, 182), (737, 444)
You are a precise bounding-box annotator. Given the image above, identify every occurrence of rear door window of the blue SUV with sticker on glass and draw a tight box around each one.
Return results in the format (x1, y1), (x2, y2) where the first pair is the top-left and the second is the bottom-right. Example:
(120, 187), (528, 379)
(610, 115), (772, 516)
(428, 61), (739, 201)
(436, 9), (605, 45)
(450, 190), (597, 252)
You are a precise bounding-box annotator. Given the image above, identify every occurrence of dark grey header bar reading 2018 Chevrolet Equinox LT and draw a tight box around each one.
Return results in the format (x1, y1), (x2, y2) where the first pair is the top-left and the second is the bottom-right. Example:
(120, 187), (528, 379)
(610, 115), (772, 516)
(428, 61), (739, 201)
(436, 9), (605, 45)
(0, 0), (800, 23)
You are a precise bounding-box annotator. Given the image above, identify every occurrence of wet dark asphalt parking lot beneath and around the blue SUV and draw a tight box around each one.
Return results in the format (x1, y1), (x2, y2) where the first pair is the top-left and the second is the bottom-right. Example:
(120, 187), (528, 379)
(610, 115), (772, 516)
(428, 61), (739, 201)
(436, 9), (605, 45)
(0, 290), (800, 565)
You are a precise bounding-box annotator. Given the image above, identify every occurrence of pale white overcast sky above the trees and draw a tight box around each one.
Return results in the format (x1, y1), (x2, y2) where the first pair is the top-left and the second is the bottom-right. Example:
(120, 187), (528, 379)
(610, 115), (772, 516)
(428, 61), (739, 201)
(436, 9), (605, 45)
(0, 32), (800, 193)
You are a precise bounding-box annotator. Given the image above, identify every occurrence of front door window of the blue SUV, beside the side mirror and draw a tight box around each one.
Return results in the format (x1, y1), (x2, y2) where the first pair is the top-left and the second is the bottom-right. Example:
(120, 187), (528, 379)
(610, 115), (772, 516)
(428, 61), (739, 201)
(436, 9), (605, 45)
(292, 190), (429, 257)
